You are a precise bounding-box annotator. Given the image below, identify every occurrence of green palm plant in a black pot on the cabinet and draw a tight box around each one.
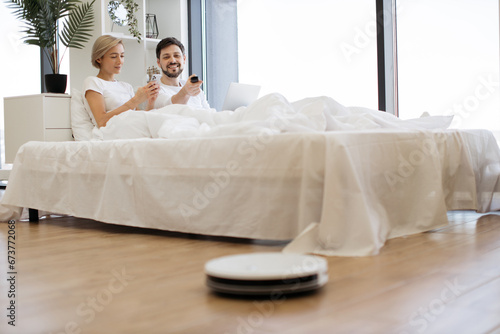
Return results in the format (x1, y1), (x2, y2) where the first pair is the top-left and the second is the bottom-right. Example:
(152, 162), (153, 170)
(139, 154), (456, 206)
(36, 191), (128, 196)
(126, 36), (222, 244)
(9, 0), (95, 93)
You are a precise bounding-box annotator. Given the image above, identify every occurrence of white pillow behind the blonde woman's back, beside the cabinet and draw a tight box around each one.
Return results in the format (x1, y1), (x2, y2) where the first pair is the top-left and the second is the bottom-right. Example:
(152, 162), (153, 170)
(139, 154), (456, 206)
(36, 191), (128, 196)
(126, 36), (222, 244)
(71, 89), (94, 141)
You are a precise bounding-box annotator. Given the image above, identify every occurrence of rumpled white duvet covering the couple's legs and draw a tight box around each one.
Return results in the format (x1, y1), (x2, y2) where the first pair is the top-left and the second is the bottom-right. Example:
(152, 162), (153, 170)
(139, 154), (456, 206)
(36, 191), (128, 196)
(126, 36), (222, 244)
(93, 94), (452, 140)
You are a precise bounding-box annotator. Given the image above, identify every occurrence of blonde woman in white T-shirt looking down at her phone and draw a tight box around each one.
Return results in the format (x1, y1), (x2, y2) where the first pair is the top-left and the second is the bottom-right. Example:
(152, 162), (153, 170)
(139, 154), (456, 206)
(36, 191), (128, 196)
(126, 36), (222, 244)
(83, 35), (160, 128)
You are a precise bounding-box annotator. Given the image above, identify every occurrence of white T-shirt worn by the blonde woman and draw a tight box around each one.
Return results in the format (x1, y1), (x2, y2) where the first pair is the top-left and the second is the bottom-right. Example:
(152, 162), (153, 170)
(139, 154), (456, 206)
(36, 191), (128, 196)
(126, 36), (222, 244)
(83, 77), (135, 112)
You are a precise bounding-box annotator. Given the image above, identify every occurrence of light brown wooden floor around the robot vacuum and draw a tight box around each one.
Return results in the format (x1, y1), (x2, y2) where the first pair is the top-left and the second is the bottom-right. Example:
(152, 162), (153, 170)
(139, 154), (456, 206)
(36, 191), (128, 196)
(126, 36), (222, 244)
(0, 212), (500, 334)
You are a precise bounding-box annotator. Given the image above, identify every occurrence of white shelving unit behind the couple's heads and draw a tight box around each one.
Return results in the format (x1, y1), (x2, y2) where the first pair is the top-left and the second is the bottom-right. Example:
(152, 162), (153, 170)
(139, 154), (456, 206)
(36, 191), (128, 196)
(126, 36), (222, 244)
(69, 0), (189, 90)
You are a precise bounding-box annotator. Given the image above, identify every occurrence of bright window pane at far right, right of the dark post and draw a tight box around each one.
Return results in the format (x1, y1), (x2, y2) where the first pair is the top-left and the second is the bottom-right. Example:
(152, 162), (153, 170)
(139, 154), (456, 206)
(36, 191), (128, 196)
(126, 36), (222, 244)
(397, 0), (500, 138)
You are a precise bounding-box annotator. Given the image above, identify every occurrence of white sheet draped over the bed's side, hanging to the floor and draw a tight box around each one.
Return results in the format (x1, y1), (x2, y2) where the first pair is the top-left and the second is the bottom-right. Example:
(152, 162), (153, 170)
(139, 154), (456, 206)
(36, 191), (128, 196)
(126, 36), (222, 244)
(0, 129), (500, 256)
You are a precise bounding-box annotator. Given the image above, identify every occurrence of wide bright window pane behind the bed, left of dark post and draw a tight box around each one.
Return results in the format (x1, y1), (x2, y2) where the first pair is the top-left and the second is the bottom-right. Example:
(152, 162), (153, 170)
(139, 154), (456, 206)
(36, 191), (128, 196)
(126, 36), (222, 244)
(237, 0), (378, 109)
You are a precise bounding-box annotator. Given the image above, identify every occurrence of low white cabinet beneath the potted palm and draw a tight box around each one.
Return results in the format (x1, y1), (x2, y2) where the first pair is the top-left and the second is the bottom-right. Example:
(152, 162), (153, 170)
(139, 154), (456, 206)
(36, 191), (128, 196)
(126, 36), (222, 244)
(4, 93), (73, 163)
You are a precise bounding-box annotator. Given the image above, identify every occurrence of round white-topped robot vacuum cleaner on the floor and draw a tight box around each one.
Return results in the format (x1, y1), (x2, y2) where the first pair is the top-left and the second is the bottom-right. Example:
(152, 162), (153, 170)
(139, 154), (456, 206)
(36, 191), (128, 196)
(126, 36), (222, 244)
(205, 253), (328, 296)
